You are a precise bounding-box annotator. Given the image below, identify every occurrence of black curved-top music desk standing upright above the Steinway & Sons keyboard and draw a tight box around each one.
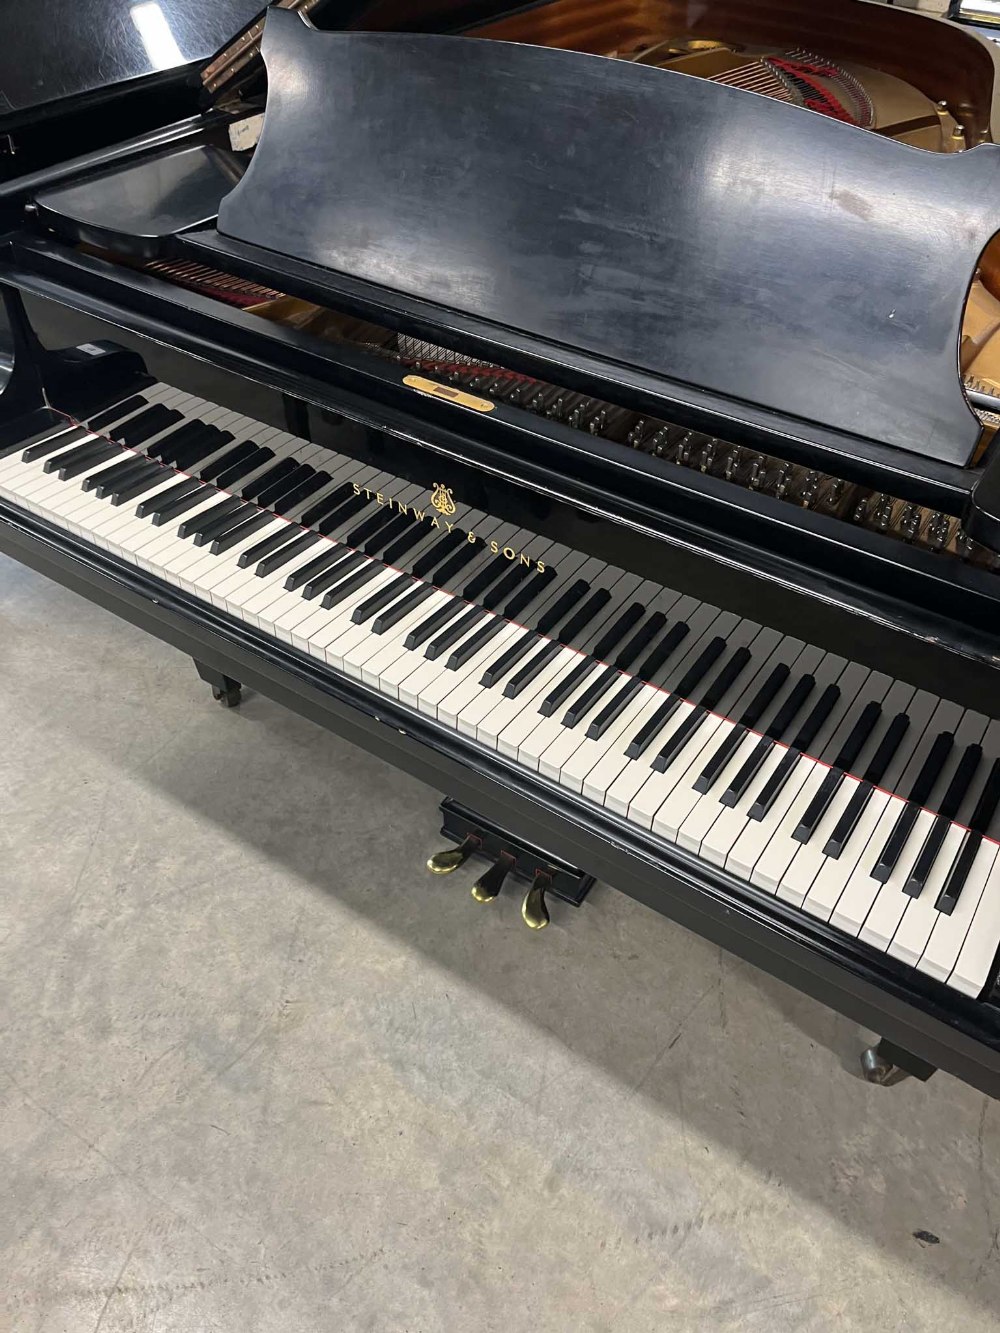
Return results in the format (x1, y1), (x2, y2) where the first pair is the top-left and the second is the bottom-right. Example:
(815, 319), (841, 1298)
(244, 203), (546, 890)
(219, 11), (1000, 467)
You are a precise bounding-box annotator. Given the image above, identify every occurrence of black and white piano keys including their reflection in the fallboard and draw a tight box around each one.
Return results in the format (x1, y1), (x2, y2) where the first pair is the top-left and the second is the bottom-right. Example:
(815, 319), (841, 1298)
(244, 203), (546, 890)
(7, 384), (1000, 997)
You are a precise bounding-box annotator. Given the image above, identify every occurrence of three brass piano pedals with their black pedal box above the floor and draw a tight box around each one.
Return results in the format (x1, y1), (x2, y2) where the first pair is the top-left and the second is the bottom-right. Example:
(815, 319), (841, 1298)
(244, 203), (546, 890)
(427, 798), (593, 930)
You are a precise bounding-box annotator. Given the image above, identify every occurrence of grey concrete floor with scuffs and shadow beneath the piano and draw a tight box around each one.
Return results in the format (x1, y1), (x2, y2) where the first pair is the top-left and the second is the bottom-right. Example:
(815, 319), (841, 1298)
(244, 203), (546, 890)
(0, 560), (1000, 1333)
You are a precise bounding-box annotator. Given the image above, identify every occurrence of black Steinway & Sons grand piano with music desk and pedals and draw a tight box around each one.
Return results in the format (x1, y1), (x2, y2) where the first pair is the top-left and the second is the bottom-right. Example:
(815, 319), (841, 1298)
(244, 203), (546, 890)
(0, 0), (1000, 1096)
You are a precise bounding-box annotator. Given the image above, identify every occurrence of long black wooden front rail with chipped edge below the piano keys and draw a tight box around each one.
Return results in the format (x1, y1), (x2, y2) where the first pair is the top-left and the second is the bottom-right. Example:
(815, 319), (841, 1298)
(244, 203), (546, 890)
(0, 485), (1000, 1098)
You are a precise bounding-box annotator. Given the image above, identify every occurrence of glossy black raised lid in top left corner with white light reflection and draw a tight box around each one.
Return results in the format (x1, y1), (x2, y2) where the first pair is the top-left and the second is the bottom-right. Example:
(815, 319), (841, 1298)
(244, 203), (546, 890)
(0, 0), (263, 124)
